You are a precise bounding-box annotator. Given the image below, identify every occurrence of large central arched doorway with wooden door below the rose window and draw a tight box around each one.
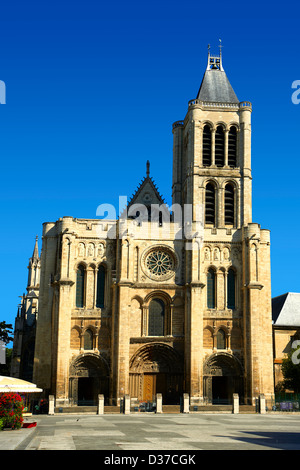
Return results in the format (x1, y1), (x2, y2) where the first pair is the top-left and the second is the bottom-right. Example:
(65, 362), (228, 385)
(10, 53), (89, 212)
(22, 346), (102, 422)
(130, 343), (183, 405)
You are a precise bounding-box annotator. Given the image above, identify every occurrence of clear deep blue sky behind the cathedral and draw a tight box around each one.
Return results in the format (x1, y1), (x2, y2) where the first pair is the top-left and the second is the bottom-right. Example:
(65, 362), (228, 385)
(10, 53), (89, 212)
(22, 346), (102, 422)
(0, 0), (300, 346)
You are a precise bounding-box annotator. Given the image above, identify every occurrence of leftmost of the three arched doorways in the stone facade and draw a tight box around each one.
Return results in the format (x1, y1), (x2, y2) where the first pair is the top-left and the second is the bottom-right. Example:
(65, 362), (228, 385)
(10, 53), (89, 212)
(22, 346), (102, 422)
(69, 354), (109, 406)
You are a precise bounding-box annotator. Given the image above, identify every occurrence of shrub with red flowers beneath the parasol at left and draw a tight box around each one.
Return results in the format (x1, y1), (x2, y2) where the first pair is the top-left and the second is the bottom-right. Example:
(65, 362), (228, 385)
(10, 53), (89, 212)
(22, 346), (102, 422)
(0, 393), (24, 429)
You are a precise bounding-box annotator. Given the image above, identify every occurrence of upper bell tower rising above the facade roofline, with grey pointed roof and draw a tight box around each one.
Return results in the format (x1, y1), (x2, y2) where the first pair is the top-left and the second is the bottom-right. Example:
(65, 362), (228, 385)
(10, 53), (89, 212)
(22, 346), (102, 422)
(173, 44), (252, 228)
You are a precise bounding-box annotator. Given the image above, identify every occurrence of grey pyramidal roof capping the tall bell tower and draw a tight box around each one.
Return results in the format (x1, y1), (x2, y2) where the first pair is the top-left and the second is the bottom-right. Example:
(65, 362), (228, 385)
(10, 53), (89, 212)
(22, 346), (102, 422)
(197, 49), (239, 103)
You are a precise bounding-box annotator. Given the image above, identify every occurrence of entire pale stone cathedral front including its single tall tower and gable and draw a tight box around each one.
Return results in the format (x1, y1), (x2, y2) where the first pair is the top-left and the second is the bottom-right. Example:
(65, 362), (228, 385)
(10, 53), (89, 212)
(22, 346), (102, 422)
(17, 53), (273, 406)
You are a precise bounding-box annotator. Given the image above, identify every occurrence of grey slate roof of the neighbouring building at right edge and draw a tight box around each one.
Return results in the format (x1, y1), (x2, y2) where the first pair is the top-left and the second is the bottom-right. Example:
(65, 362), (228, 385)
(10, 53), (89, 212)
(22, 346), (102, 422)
(272, 292), (300, 327)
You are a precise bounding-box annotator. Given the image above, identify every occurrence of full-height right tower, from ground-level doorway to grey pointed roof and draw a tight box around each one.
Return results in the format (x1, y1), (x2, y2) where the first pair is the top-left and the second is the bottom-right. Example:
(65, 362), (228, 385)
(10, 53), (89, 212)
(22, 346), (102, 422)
(172, 44), (273, 403)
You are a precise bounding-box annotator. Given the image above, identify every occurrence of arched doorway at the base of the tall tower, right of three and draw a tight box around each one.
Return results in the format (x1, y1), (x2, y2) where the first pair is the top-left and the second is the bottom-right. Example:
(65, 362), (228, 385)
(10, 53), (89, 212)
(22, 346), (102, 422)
(203, 353), (244, 404)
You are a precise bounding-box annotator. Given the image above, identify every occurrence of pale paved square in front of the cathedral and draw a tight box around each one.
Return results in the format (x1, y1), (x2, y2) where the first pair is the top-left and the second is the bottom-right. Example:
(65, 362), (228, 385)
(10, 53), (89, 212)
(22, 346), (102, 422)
(0, 413), (300, 453)
